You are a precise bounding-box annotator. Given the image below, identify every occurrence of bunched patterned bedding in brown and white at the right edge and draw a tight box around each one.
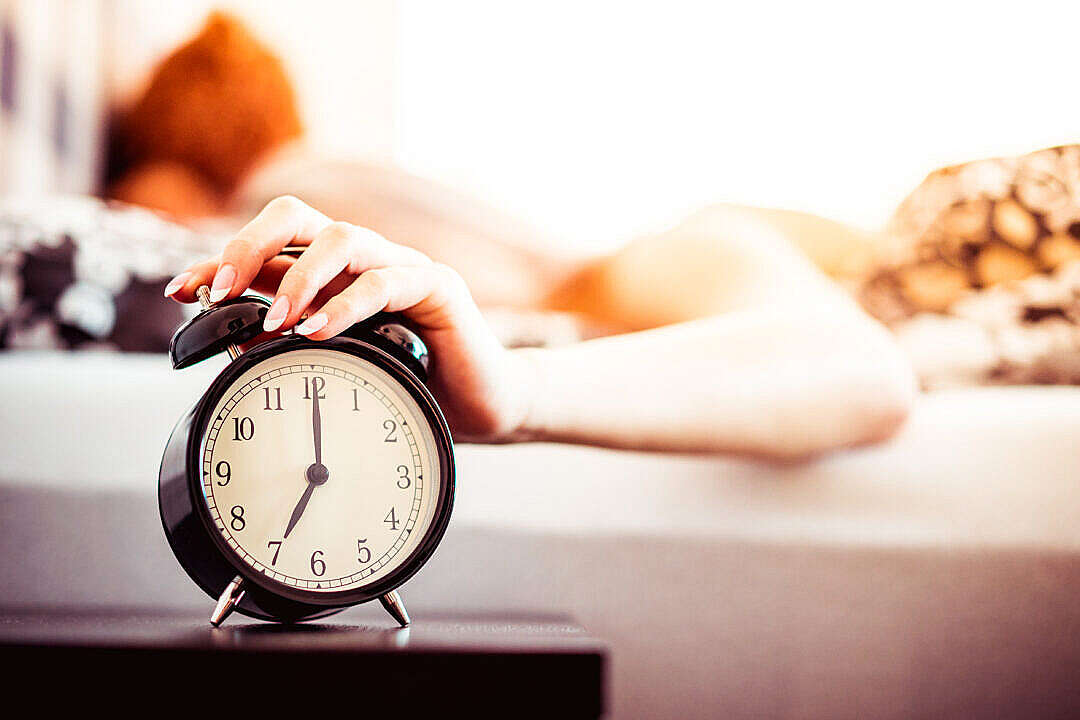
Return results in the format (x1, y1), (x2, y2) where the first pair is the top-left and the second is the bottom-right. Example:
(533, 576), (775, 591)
(860, 145), (1080, 388)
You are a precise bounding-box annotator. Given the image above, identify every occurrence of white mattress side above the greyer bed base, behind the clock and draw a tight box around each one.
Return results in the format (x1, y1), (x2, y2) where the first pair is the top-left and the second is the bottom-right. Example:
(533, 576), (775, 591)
(0, 353), (1080, 549)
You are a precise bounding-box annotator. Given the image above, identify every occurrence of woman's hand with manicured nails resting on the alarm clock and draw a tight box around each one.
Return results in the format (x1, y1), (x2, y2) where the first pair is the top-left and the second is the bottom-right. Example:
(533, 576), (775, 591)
(165, 195), (531, 441)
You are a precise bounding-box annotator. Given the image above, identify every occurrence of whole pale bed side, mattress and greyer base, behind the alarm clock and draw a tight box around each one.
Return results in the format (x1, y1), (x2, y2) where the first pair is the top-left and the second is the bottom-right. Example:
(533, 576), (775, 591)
(0, 352), (1080, 720)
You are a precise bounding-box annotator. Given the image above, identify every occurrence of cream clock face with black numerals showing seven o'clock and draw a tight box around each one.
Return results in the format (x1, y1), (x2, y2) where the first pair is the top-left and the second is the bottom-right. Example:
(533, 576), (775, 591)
(200, 349), (442, 595)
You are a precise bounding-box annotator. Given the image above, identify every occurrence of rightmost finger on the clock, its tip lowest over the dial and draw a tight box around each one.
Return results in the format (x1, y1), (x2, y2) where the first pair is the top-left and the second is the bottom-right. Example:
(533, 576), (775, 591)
(296, 263), (471, 340)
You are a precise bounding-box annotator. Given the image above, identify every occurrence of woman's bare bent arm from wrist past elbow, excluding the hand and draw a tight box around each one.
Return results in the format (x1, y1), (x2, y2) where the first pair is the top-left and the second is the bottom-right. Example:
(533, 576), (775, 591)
(519, 205), (915, 458)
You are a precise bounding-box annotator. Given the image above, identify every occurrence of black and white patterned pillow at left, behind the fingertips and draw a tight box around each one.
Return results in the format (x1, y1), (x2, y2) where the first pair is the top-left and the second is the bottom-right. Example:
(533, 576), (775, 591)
(0, 196), (217, 352)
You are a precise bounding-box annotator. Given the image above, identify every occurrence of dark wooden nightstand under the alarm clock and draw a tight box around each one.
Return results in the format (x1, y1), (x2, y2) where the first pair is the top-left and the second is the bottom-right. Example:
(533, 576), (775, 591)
(0, 609), (607, 718)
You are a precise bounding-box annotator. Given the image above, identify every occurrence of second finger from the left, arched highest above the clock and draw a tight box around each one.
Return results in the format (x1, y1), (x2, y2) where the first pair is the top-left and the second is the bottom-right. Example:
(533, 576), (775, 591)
(203, 195), (330, 302)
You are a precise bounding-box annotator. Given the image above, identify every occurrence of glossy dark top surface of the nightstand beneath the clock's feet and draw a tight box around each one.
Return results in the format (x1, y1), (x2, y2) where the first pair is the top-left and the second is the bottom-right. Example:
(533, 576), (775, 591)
(0, 608), (605, 656)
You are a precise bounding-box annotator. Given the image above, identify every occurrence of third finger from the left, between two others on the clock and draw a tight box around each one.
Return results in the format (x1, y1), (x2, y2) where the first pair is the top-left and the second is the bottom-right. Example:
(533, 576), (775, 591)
(264, 222), (431, 330)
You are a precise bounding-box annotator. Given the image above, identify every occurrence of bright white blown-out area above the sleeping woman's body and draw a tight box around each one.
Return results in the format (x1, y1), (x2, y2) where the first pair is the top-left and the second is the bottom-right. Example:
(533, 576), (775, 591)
(397, 0), (1080, 253)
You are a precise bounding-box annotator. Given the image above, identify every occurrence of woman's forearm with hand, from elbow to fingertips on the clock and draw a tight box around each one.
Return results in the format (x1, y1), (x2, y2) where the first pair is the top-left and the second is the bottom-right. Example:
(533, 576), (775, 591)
(165, 198), (912, 458)
